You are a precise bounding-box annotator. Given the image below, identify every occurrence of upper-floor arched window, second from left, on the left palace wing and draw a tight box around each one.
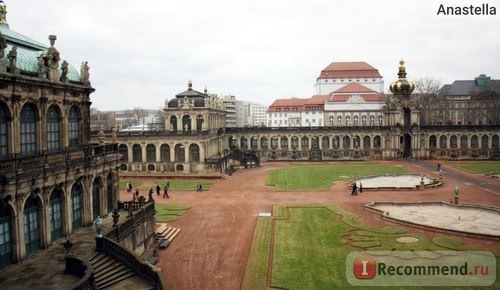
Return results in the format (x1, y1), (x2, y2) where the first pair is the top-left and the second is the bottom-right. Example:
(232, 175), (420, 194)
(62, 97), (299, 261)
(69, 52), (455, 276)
(20, 104), (37, 154)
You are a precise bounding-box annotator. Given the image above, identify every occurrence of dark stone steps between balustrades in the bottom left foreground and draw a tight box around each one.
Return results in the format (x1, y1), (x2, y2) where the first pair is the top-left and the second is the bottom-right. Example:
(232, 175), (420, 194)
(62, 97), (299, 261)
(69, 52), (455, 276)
(89, 253), (140, 289)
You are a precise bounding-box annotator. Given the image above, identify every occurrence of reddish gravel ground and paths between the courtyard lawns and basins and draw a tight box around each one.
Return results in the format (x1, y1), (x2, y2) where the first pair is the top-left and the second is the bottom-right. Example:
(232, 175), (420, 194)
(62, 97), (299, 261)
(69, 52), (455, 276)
(121, 161), (500, 290)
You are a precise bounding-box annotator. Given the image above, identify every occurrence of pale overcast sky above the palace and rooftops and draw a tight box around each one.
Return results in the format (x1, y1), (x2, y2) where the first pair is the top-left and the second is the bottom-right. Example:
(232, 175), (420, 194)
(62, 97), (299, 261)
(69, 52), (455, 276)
(4, 0), (500, 110)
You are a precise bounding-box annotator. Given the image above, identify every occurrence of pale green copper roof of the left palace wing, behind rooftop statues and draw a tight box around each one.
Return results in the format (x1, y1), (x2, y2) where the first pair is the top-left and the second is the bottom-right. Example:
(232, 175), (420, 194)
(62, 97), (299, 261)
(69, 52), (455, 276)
(0, 23), (81, 83)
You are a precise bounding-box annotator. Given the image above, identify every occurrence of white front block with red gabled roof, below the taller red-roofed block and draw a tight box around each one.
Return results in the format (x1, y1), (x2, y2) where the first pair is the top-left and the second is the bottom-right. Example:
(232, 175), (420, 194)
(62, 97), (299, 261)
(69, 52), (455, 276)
(325, 83), (385, 126)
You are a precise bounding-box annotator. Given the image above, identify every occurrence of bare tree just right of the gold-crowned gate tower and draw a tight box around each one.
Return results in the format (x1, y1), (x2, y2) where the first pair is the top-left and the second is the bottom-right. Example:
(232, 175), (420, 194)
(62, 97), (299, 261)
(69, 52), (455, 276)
(415, 77), (441, 125)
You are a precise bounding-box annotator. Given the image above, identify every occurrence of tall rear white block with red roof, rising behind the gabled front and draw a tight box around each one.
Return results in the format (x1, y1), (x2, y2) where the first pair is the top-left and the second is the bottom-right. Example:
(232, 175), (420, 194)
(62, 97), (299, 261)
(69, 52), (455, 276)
(316, 61), (384, 95)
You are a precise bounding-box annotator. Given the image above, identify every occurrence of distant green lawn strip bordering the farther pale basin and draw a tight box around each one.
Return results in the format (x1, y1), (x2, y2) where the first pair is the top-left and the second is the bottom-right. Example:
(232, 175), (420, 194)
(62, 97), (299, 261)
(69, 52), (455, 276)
(266, 162), (411, 190)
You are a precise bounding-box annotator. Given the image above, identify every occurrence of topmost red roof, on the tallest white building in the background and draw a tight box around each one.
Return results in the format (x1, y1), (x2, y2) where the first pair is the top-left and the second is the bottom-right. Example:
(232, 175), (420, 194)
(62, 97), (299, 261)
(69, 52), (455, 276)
(318, 61), (382, 79)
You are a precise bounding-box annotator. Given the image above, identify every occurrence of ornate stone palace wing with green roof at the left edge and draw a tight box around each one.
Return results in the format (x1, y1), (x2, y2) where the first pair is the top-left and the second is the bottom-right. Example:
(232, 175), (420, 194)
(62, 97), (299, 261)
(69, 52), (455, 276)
(0, 1), (119, 269)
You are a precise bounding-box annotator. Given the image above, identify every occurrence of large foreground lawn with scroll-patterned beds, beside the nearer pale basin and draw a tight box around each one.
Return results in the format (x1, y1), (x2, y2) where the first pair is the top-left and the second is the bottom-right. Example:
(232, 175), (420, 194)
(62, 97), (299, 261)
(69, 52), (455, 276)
(241, 205), (500, 289)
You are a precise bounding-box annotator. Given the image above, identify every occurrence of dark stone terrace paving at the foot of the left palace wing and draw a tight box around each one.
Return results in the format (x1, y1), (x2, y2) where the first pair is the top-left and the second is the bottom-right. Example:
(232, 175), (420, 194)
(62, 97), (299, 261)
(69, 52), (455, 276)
(0, 215), (151, 290)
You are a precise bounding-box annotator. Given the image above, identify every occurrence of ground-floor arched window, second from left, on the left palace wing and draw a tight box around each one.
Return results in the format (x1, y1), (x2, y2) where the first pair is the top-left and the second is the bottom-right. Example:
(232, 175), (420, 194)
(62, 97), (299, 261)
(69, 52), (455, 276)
(24, 197), (40, 255)
